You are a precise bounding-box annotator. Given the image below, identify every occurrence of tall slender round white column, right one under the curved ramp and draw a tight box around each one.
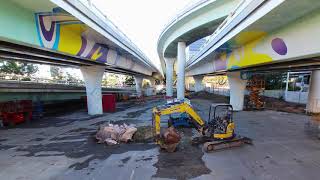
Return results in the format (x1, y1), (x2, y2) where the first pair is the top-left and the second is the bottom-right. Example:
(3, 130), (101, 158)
(177, 42), (186, 100)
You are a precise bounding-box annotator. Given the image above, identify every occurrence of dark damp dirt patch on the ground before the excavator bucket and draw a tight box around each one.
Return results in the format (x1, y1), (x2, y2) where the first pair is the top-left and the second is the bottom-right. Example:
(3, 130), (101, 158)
(154, 128), (211, 180)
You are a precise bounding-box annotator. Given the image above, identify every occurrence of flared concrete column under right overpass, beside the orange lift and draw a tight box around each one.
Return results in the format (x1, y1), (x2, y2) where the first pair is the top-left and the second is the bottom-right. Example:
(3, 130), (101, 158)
(227, 72), (247, 111)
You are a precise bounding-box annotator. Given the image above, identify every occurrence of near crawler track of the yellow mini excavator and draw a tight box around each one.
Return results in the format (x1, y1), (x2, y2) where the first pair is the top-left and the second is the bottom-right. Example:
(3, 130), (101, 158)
(203, 136), (252, 152)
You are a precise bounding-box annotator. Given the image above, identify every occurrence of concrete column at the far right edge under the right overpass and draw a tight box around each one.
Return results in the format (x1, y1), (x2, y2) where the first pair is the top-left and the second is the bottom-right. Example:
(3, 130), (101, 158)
(307, 70), (320, 113)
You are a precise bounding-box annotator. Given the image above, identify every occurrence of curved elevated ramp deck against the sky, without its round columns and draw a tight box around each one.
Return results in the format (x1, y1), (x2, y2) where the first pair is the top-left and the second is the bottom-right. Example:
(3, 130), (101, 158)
(157, 0), (241, 73)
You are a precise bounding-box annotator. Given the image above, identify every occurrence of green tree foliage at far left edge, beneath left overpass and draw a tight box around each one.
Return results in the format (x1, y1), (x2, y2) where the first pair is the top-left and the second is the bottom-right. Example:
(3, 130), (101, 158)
(0, 61), (38, 77)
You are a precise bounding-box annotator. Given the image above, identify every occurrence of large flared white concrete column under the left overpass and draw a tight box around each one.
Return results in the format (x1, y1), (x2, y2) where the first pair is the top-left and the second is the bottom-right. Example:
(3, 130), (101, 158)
(80, 66), (105, 115)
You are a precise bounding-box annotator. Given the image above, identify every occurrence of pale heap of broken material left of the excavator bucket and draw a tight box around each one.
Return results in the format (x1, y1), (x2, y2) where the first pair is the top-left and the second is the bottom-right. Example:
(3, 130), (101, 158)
(96, 123), (137, 145)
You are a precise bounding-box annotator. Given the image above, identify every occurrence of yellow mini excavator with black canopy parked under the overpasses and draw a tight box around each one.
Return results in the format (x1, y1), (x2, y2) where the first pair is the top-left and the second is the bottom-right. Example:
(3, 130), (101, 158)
(152, 99), (252, 152)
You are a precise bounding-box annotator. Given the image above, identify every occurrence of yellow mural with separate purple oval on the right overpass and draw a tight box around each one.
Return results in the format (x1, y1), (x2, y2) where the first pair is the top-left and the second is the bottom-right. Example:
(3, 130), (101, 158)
(213, 32), (288, 71)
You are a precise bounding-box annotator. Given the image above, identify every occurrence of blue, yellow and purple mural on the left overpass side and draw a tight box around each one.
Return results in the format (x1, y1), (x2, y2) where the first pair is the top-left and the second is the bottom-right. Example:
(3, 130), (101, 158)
(35, 8), (109, 63)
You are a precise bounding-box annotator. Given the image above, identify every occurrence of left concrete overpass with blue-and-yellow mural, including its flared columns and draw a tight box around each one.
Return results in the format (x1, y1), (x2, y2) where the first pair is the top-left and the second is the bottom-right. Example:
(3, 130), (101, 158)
(0, 0), (161, 114)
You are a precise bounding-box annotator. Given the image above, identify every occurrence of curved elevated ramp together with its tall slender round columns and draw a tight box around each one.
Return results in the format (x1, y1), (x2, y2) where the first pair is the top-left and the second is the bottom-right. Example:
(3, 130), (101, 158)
(157, 0), (241, 99)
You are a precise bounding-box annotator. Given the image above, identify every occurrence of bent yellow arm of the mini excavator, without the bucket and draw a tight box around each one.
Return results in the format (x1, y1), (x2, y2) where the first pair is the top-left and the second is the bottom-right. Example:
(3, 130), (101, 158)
(152, 102), (205, 136)
